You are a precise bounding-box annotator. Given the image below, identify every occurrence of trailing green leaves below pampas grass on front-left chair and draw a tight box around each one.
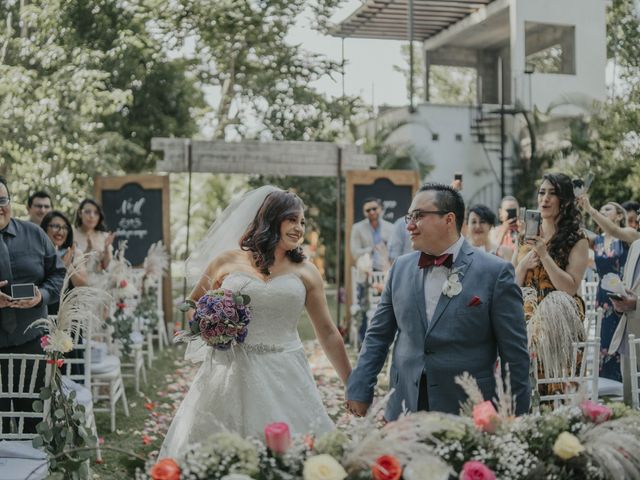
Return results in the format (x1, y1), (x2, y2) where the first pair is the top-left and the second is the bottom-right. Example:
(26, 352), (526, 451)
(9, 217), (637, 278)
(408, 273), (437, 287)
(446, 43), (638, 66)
(33, 357), (98, 479)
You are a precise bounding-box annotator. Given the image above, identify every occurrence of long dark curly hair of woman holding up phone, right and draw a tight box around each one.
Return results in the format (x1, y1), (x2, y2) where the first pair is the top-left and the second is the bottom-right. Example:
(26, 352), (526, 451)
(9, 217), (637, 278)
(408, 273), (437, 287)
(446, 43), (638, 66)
(542, 173), (584, 270)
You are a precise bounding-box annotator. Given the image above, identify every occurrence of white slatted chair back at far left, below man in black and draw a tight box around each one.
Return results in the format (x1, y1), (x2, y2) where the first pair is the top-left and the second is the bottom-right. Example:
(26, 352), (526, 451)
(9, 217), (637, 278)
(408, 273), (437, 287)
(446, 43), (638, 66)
(0, 353), (51, 440)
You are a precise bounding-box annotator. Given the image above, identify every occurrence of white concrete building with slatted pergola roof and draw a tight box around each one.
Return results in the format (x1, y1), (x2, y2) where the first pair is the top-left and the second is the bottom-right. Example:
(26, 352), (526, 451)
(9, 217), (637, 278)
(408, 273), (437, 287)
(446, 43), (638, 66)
(334, 0), (607, 207)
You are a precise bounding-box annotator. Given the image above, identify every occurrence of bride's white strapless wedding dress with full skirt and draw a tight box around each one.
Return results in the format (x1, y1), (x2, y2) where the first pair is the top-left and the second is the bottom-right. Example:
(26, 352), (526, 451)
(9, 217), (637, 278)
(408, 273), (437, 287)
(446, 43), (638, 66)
(159, 272), (334, 458)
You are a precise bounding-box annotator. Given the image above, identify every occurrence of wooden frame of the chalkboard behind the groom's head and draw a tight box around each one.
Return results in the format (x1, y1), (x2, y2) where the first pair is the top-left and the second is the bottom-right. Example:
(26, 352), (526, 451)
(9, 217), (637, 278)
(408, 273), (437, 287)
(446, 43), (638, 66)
(344, 170), (420, 320)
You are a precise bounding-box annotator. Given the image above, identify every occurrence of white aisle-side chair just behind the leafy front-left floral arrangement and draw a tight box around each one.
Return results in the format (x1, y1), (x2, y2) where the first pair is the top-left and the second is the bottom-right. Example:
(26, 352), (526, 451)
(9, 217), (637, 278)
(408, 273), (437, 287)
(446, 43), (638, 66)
(91, 320), (129, 432)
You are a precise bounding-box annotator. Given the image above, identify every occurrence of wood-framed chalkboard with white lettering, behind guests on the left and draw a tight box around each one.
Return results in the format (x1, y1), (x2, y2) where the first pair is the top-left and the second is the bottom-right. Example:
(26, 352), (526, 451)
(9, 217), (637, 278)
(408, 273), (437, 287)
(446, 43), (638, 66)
(94, 175), (172, 319)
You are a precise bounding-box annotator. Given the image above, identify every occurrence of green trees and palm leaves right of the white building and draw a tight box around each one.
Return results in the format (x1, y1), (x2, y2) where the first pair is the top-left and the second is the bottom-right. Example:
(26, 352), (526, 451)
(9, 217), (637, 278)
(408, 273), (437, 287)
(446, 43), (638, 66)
(516, 0), (640, 204)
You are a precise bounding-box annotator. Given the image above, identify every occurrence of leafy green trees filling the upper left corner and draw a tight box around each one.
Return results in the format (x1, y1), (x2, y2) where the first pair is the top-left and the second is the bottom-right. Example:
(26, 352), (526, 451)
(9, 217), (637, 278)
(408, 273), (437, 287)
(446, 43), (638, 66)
(0, 0), (204, 212)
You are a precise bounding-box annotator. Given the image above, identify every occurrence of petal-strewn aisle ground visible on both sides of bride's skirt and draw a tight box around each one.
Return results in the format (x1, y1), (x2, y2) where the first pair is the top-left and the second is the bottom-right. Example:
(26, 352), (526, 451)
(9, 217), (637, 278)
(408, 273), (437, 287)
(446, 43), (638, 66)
(141, 341), (370, 455)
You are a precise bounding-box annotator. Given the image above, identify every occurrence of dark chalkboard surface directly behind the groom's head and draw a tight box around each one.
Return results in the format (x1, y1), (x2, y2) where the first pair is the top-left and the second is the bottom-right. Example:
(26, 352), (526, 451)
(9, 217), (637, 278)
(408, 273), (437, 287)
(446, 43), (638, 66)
(352, 177), (414, 223)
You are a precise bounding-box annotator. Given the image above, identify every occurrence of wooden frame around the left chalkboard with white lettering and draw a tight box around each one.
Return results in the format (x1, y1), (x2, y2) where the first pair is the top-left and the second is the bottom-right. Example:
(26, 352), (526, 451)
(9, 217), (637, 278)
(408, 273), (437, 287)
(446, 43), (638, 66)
(93, 175), (173, 323)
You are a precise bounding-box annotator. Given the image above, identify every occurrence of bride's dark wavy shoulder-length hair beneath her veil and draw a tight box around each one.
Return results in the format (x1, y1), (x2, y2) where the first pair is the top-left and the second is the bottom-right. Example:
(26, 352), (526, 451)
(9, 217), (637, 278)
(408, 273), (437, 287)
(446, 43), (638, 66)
(240, 190), (306, 275)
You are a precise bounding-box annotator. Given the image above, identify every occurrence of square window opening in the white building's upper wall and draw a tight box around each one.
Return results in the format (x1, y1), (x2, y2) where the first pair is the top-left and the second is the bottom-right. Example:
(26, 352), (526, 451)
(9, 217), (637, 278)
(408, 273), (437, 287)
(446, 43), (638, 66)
(524, 22), (576, 75)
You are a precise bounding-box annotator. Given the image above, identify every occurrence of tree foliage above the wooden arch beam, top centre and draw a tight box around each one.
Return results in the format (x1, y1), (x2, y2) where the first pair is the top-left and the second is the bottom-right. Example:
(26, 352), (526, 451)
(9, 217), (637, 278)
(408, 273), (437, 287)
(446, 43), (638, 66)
(158, 0), (356, 140)
